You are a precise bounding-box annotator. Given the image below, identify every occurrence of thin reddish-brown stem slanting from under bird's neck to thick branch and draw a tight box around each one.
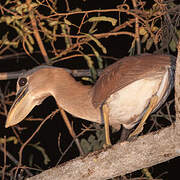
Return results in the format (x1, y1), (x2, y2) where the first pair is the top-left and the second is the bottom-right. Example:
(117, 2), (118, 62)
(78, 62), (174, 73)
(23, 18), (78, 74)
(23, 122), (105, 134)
(59, 107), (84, 156)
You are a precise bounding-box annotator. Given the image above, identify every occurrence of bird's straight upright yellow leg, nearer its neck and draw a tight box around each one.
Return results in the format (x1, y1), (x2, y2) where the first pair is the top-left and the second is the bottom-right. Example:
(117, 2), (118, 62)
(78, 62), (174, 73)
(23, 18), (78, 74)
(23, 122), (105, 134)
(102, 104), (111, 146)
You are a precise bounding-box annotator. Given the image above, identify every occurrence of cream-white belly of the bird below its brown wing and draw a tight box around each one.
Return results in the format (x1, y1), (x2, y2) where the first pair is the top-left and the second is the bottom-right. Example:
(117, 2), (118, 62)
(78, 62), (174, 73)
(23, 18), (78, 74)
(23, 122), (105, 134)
(107, 78), (162, 129)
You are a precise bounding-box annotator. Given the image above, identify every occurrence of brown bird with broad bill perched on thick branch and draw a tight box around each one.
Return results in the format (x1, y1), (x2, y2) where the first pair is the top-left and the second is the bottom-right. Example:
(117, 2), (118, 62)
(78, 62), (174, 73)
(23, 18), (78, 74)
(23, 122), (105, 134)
(5, 54), (176, 145)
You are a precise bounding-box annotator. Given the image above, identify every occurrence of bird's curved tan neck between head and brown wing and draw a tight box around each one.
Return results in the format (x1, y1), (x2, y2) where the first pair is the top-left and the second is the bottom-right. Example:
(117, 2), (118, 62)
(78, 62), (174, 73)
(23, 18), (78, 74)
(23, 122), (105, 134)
(53, 72), (101, 123)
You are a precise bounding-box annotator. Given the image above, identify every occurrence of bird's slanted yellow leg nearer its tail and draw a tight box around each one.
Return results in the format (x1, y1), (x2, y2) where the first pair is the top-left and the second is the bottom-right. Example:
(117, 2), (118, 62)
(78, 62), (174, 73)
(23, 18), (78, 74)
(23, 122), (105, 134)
(129, 95), (158, 137)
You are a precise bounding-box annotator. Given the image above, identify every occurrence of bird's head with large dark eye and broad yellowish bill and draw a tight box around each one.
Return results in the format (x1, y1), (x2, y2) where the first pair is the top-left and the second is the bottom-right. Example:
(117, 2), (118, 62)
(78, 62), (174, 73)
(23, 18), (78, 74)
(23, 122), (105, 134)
(5, 66), (55, 128)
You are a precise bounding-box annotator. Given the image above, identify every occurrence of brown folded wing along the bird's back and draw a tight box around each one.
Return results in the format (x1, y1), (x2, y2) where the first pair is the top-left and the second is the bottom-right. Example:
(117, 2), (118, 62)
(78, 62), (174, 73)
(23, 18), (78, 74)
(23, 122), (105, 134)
(92, 54), (174, 107)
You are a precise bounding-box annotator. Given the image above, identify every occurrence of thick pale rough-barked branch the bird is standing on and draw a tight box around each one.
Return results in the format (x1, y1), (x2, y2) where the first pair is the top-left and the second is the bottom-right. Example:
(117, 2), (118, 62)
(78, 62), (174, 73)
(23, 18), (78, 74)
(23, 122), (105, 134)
(26, 125), (180, 180)
